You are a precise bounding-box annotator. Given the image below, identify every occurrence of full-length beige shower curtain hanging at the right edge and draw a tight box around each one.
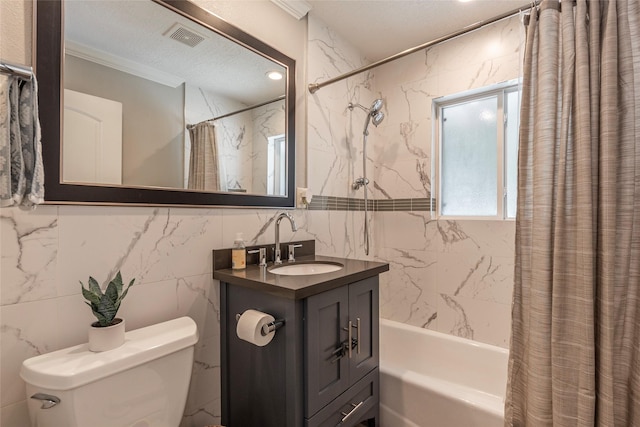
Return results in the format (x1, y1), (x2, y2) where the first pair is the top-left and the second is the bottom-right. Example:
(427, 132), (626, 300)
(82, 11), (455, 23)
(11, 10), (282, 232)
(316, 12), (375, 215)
(505, 0), (640, 427)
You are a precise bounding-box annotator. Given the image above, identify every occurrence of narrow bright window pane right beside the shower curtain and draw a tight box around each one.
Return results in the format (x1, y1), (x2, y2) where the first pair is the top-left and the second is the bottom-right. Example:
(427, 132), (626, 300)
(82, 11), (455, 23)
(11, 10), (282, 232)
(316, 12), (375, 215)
(505, 90), (520, 218)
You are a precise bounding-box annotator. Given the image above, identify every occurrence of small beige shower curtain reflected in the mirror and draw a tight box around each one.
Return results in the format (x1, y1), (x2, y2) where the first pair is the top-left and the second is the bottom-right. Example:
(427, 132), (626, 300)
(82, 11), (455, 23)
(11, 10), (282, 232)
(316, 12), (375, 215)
(187, 122), (220, 191)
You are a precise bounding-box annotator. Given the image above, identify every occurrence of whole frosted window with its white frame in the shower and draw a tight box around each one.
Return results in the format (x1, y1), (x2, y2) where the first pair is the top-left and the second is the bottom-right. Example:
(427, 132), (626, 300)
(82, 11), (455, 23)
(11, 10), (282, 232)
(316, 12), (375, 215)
(433, 81), (520, 219)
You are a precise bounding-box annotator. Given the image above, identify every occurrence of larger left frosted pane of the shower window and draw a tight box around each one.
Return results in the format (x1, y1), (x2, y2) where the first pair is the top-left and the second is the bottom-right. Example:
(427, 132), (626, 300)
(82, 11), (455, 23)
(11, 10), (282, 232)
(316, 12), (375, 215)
(440, 96), (498, 216)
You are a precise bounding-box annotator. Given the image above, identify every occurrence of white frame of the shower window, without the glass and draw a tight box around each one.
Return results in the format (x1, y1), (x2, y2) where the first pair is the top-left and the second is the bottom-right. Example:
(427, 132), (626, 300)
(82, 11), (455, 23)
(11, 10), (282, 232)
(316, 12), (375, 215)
(431, 80), (520, 221)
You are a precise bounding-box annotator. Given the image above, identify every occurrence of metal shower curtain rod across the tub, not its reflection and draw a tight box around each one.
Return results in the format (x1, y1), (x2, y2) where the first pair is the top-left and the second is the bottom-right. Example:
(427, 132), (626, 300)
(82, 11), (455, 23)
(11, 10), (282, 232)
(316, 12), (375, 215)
(309, 0), (541, 94)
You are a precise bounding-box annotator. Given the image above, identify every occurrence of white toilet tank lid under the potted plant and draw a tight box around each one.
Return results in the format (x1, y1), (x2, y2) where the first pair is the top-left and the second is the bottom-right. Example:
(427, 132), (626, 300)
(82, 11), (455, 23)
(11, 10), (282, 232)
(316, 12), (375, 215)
(20, 317), (198, 390)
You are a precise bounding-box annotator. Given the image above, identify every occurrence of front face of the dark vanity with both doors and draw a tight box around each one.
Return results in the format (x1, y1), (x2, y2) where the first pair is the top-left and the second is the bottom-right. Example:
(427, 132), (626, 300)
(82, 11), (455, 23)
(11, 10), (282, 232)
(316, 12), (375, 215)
(304, 277), (379, 427)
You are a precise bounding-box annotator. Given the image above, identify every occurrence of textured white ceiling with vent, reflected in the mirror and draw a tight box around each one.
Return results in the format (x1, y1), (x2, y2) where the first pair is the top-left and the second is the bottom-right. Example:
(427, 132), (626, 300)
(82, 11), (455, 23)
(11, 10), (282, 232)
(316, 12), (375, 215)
(65, 0), (285, 105)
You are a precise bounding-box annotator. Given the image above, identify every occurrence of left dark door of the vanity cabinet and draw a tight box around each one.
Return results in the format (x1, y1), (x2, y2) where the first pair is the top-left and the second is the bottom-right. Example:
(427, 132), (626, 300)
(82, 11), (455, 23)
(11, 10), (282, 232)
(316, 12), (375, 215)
(305, 286), (349, 417)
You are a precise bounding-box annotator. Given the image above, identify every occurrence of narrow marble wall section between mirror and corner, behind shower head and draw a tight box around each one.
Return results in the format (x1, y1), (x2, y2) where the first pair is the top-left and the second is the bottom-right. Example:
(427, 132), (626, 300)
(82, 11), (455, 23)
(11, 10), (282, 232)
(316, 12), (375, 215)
(304, 11), (377, 258)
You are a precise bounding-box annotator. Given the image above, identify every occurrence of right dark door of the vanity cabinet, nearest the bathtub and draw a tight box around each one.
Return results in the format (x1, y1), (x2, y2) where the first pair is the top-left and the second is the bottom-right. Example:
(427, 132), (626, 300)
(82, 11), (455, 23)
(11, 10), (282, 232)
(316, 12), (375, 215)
(349, 276), (379, 384)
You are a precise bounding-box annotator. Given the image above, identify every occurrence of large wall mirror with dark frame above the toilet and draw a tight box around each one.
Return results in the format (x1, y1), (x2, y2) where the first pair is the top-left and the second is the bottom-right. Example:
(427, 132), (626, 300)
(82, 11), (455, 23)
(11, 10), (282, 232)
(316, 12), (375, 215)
(34, 0), (295, 207)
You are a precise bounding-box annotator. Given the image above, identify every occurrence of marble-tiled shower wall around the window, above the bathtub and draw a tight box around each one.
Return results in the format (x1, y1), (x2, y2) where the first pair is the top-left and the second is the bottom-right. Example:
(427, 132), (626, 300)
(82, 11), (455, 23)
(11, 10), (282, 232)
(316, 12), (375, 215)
(372, 16), (524, 347)
